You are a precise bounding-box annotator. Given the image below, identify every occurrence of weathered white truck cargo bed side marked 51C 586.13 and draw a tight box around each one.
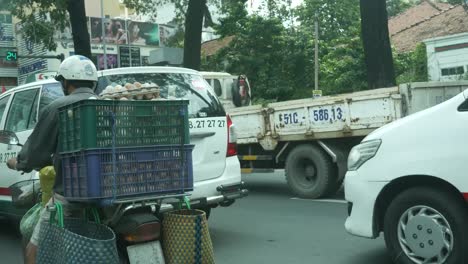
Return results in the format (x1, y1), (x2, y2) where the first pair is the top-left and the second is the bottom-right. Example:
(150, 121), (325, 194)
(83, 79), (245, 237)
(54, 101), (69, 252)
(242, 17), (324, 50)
(229, 87), (402, 145)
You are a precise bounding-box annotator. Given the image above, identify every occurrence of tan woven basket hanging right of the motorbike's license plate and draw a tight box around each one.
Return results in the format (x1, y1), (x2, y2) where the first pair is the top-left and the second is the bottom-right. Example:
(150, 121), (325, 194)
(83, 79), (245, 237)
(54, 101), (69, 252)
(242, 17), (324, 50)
(163, 210), (215, 264)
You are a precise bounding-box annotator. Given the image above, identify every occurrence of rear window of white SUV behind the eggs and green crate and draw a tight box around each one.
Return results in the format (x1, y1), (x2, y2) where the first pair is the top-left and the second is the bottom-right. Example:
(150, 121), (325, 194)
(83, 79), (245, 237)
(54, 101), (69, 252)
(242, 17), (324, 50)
(96, 73), (225, 118)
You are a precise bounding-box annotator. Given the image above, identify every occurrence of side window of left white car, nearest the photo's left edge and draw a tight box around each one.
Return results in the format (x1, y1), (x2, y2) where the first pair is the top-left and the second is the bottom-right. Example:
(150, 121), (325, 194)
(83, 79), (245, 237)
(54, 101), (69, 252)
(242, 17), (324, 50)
(5, 89), (39, 132)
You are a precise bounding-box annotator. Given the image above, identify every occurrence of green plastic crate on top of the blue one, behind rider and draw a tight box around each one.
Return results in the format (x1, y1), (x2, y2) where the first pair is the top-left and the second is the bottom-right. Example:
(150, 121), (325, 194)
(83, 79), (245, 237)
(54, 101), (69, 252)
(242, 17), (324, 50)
(59, 100), (190, 152)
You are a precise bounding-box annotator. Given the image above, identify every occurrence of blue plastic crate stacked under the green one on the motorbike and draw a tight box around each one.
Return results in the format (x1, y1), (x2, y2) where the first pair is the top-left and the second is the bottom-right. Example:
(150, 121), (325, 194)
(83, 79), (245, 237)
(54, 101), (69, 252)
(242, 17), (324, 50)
(61, 145), (194, 206)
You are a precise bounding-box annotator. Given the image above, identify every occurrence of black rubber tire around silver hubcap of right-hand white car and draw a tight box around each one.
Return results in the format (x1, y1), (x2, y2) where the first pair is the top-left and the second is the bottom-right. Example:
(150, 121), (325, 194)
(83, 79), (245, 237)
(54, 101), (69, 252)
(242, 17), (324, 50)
(384, 187), (468, 264)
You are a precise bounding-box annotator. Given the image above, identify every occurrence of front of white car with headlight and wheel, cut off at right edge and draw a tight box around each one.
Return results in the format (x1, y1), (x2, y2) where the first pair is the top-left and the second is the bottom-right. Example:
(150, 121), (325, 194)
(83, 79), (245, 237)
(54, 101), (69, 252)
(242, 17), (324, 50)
(345, 90), (468, 264)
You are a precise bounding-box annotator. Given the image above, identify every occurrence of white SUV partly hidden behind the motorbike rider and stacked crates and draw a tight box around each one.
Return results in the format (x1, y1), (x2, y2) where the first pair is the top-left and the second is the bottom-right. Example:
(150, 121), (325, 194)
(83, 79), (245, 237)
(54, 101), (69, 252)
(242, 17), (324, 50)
(0, 67), (247, 219)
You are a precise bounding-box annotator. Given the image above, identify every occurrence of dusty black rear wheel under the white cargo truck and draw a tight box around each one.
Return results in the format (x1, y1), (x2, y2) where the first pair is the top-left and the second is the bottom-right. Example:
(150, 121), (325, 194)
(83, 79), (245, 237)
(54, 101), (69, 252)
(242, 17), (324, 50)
(285, 145), (336, 199)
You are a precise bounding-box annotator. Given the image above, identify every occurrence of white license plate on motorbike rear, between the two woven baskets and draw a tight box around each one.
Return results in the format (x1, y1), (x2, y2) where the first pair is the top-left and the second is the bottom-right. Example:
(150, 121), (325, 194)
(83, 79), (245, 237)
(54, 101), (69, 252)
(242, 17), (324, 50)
(127, 241), (164, 264)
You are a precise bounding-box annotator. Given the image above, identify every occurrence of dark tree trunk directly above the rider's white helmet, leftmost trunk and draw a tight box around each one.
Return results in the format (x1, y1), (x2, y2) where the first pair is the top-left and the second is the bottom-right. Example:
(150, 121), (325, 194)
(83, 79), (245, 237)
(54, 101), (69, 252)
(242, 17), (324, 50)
(67, 0), (91, 59)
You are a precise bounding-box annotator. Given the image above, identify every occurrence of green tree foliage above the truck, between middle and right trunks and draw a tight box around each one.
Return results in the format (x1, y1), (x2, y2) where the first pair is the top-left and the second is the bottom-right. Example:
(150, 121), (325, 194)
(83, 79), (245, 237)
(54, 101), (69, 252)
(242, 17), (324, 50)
(203, 0), (367, 101)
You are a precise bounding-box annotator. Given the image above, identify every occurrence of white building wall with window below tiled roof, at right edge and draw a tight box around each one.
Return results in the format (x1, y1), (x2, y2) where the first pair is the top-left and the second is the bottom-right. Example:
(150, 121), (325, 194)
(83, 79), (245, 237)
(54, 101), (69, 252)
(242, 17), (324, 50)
(424, 33), (468, 81)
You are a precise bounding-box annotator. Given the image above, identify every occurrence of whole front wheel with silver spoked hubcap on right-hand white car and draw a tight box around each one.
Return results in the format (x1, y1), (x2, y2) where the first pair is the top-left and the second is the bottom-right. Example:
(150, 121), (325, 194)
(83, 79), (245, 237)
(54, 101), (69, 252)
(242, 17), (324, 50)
(384, 187), (468, 264)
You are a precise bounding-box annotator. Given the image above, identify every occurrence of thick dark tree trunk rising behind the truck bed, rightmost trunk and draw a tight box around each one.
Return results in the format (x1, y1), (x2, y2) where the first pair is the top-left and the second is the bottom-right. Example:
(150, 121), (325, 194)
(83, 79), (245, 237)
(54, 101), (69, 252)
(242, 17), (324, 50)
(360, 0), (396, 89)
